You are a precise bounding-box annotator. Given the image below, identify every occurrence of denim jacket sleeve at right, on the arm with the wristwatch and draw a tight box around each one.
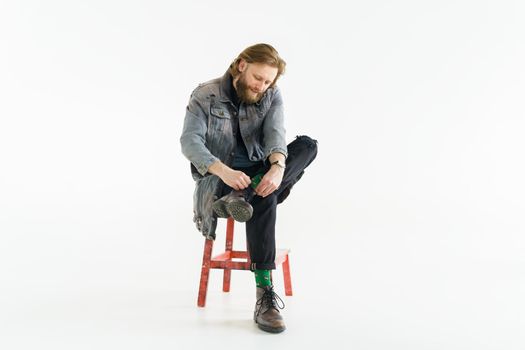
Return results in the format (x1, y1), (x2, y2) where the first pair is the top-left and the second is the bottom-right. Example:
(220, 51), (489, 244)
(263, 87), (288, 159)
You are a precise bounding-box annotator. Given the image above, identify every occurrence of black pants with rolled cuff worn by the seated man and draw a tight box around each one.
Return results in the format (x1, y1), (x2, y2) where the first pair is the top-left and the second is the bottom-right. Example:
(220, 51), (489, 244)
(223, 136), (317, 270)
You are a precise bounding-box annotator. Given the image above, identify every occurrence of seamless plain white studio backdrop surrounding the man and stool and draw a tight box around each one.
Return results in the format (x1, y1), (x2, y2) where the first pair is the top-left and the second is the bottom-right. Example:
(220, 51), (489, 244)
(0, 0), (525, 349)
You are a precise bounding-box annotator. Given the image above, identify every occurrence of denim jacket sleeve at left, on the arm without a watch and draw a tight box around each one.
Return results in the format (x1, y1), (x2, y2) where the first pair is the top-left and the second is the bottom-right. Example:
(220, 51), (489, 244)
(180, 92), (218, 176)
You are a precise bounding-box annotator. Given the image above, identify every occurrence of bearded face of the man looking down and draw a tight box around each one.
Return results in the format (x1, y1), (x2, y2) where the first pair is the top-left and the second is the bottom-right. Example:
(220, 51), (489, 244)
(233, 61), (278, 104)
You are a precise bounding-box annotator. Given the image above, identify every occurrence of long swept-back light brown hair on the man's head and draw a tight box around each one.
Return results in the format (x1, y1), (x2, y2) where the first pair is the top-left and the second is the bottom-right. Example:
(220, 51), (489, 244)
(229, 44), (286, 86)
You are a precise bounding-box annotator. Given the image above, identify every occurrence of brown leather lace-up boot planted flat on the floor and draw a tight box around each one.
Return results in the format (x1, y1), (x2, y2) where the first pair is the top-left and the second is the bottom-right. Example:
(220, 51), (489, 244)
(253, 286), (286, 333)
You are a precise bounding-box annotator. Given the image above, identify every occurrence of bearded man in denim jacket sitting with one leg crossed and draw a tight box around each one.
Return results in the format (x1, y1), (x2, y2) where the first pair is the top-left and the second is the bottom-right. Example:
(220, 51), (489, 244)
(180, 44), (317, 333)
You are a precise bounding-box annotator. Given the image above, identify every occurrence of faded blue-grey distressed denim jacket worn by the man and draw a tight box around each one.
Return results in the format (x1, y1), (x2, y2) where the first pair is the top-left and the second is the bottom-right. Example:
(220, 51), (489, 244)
(180, 72), (287, 239)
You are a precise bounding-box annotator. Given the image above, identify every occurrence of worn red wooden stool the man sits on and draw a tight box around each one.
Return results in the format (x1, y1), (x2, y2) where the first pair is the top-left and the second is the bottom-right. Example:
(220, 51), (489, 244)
(197, 218), (292, 307)
